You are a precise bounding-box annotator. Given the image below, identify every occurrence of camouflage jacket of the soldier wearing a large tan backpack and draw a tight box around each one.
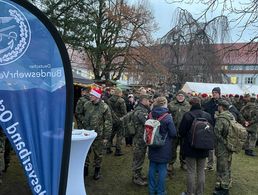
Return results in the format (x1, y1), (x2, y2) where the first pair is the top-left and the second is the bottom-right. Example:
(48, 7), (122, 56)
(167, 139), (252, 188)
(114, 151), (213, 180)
(214, 110), (234, 156)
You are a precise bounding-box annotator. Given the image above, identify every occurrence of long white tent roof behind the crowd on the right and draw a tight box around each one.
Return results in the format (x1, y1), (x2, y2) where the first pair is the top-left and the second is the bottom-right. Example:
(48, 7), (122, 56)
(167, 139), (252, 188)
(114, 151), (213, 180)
(182, 82), (245, 95)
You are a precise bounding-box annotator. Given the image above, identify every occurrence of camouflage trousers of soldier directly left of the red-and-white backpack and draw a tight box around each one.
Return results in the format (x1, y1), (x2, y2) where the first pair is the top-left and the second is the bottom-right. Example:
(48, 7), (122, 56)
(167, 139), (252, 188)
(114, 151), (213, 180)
(132, 137), (147, 178)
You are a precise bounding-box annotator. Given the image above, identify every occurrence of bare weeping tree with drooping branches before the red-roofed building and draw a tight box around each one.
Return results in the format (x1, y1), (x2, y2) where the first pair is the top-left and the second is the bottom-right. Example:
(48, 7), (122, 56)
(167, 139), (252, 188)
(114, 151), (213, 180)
(160, 8), (228, 87)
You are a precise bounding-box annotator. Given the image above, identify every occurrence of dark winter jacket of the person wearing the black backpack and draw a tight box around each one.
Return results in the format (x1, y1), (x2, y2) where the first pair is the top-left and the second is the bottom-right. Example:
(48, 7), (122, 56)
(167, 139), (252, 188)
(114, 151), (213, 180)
(179, 105), (213, 158)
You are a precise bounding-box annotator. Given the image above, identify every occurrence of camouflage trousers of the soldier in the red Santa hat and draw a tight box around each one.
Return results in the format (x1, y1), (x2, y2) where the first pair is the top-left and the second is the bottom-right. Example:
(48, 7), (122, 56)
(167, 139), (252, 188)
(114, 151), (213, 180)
(86, 137), (103, 167)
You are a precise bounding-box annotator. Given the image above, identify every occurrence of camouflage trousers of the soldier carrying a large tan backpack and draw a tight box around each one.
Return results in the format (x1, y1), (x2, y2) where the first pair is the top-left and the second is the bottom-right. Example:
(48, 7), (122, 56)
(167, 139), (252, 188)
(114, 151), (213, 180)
(216, 150), (232, 189)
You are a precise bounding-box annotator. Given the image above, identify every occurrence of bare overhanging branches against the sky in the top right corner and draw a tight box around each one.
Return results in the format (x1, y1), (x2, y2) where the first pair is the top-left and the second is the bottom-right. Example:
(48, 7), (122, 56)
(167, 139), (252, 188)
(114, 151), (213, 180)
(166, 0), (258, 42)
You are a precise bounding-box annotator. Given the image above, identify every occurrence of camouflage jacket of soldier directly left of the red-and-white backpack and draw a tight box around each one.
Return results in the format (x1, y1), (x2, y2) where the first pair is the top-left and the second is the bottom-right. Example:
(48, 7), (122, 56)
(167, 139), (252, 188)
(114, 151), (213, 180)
(133, 103), (150, 139)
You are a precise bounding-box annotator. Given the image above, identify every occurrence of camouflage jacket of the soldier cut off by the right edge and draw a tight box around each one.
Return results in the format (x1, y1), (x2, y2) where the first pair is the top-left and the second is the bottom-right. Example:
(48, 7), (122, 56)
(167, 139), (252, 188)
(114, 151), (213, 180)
(240, 102), (258, 132)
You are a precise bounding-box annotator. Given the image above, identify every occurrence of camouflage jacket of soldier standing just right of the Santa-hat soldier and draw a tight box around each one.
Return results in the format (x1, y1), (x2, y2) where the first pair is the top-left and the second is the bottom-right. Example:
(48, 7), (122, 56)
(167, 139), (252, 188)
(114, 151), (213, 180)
(108, 95), (127, 122)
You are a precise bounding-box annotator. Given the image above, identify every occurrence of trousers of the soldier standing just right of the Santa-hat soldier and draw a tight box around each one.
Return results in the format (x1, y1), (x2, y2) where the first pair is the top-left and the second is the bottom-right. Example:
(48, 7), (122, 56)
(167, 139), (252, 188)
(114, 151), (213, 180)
(107, 123), (123, 150)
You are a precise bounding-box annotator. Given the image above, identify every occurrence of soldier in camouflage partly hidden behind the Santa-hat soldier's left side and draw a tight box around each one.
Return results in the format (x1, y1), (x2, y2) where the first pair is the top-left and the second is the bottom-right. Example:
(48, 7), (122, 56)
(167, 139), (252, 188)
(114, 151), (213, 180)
(75, 88), (90, 129)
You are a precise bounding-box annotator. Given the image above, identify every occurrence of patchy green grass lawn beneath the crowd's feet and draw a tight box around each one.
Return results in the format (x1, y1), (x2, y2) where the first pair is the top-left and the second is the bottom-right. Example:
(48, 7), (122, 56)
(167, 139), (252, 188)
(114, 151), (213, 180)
(0, 147), (258, 195)
